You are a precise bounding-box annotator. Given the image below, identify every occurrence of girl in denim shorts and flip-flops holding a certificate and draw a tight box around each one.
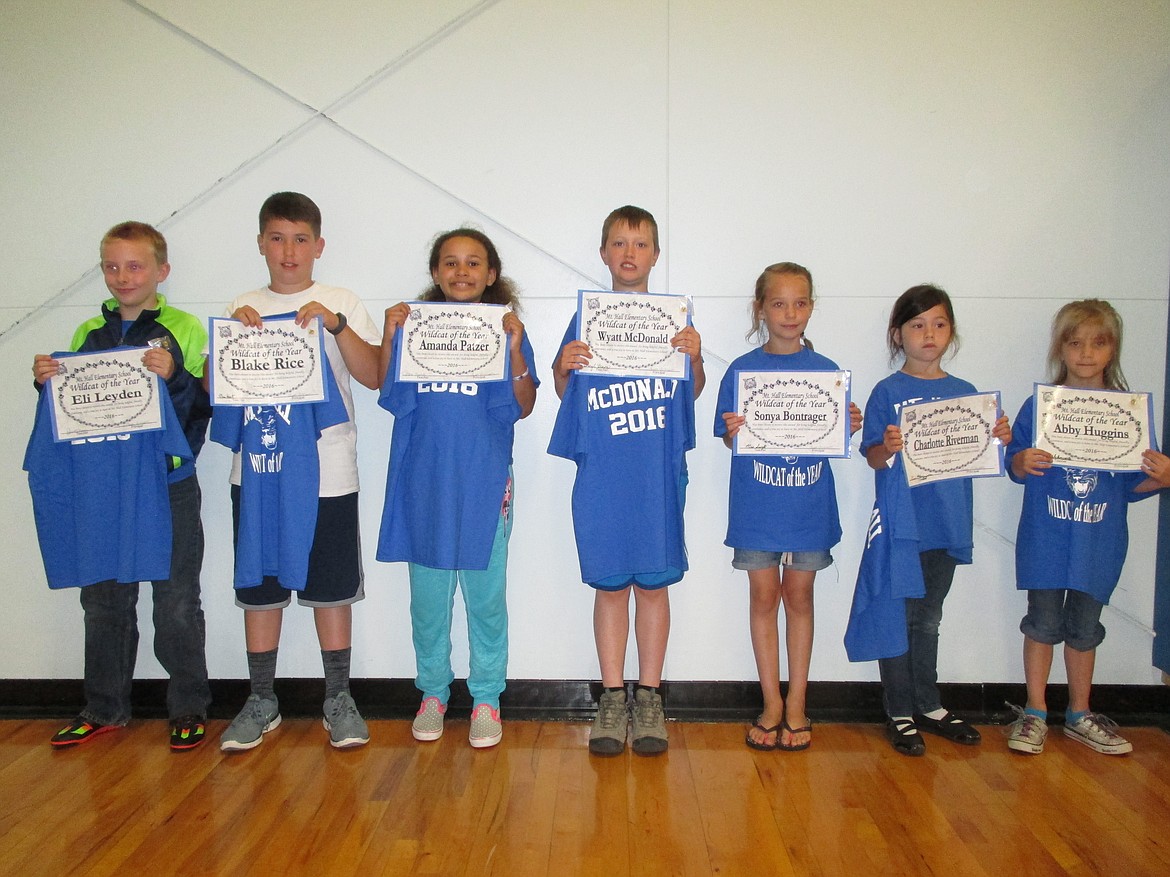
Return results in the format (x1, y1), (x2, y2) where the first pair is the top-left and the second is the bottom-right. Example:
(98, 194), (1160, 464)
(715, 262), (861, 752)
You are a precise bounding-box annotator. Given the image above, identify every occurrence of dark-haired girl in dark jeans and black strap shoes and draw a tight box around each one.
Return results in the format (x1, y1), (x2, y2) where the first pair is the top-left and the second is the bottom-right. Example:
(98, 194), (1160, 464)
(861, 284), (1011, 755)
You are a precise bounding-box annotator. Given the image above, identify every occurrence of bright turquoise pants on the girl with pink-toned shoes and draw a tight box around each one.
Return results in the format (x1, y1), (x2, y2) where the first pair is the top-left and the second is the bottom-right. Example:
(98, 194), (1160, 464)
(408, 513), (511, 710)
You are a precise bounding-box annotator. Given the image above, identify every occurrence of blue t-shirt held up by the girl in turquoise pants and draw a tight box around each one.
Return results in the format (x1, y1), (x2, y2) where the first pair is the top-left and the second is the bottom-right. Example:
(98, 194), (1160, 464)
(377, 333), (541, 569)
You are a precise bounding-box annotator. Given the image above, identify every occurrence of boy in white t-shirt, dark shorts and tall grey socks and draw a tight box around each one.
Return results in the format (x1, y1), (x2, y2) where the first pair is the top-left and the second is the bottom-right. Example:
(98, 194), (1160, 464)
(220, 192), (381, 752)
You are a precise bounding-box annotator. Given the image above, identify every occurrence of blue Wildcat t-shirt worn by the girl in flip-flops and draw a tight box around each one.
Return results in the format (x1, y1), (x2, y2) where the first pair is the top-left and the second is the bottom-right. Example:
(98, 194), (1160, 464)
(715, 347), (841, 552)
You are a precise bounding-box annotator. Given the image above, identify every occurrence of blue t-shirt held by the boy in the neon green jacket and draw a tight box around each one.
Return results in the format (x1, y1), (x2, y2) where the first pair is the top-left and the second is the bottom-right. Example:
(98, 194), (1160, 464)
(25, 382), (194, 588)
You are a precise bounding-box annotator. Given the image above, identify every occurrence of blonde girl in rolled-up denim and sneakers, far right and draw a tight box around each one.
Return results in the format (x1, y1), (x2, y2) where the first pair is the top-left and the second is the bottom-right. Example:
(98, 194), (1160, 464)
(1007, 298), (1170, 755)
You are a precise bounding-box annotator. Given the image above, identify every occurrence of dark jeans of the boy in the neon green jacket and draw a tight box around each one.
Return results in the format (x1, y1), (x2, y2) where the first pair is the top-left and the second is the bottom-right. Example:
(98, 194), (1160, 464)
(81, 475), (212, 725)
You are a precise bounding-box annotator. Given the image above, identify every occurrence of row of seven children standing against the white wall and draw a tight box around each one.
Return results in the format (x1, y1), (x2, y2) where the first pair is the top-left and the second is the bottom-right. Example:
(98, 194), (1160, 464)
(26, 192), (1170, 755)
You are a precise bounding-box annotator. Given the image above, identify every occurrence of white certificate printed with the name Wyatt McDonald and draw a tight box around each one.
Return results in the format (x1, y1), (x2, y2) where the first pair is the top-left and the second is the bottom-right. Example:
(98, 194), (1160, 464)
(577, 289), (691, 380)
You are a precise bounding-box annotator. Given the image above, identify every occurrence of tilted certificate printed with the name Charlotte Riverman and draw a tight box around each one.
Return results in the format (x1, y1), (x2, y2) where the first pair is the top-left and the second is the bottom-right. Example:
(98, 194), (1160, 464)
(899, 393), (1004, 488)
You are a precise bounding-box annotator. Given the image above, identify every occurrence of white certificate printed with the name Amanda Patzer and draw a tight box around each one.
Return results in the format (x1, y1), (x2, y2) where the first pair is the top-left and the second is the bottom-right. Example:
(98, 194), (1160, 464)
(397, 302), (508, 382)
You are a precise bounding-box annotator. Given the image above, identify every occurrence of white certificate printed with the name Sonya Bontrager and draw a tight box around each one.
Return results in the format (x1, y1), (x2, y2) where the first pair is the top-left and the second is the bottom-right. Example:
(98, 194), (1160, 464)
(732, 371), (851, 457)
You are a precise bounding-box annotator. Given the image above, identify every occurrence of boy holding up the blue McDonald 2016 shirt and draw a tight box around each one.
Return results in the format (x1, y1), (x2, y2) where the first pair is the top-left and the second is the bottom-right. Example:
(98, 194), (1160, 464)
(549, 206), (706, 755)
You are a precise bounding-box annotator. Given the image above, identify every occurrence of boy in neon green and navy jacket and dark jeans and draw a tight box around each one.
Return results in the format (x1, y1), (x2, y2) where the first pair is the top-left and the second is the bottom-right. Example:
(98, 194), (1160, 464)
(33, 222), (212, 751)
